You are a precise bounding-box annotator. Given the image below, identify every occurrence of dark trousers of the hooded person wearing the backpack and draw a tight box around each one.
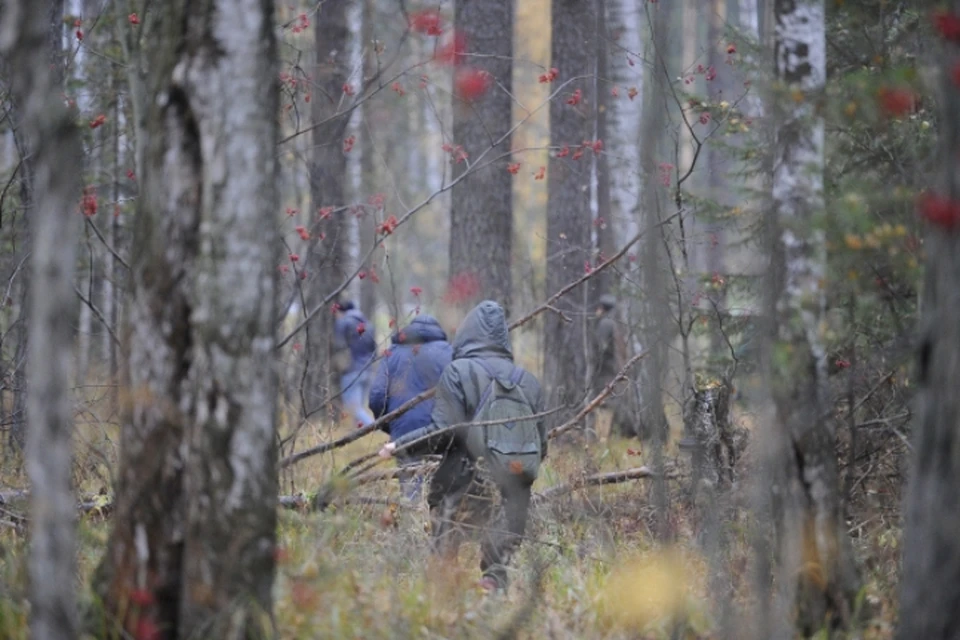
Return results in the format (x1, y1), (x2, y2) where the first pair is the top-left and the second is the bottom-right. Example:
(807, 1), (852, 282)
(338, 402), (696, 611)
(427, 456), (531, 589)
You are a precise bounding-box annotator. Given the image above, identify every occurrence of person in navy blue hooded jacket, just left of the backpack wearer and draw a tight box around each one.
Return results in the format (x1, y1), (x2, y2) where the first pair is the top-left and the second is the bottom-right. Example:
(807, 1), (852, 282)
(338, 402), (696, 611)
(370, 314), (453, 500)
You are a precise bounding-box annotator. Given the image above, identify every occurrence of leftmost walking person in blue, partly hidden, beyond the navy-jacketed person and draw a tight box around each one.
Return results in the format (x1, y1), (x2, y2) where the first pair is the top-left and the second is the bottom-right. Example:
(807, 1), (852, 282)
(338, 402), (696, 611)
(333, 301), (377, 427)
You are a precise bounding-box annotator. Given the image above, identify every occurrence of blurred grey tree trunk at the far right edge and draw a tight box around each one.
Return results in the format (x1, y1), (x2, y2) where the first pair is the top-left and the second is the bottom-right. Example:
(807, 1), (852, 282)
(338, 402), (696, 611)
(897, 0), (960, 640)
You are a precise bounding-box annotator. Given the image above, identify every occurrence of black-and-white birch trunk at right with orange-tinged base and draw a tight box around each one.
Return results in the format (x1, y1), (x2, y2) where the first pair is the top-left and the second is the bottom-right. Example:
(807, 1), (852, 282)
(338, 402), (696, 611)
(772, 0), (859, 635)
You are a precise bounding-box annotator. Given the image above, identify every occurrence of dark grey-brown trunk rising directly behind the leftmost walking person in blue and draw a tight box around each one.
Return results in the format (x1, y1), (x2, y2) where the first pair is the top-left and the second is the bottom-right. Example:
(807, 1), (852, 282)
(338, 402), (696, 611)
(300, 0), (350, 415)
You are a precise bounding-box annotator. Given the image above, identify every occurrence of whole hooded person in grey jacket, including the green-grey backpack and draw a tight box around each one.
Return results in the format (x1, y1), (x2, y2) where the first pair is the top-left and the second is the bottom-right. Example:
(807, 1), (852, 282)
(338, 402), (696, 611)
(380, 300), (547, 591)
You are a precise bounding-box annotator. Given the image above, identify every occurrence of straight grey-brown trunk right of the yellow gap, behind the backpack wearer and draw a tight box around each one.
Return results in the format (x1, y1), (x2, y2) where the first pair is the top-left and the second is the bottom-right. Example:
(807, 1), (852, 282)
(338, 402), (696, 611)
(544, 0), (596, 424)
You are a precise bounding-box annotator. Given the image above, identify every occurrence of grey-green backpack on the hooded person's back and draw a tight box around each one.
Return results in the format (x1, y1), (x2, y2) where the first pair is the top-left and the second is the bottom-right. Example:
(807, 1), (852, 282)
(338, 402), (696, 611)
(466, 362), (542, 484)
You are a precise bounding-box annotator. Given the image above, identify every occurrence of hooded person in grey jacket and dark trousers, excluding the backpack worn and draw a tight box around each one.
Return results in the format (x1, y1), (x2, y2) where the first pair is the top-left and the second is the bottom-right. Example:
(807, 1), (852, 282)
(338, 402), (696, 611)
(380, 300), (547, 591)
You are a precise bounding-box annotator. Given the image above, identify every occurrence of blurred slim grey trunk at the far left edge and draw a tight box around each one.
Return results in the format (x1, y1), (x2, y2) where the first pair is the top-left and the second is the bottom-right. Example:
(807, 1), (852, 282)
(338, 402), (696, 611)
(0, 0), (83, 639)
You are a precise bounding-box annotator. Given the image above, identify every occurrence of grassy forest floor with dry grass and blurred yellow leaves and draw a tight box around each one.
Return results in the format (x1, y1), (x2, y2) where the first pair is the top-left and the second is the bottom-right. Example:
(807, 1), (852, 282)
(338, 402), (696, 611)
(0, 404), (899, 640)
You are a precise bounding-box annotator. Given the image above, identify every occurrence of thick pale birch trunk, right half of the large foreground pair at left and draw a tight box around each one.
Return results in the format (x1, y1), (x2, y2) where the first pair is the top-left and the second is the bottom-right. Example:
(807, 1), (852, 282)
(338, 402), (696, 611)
(174, 0), (280, 638)
